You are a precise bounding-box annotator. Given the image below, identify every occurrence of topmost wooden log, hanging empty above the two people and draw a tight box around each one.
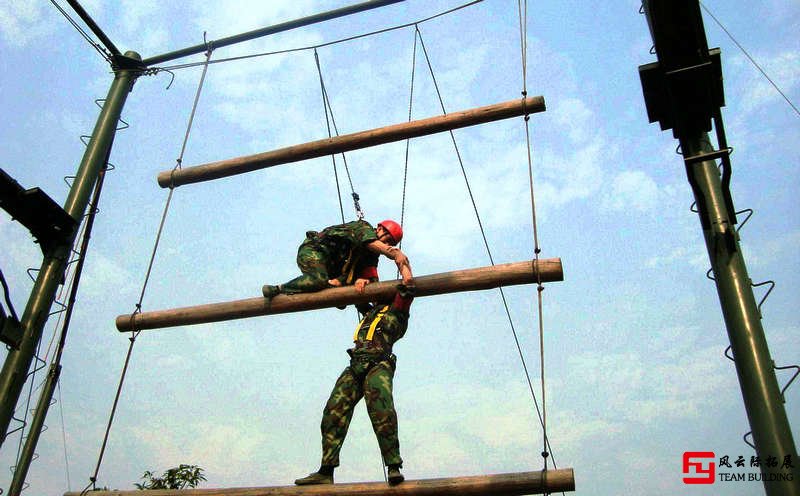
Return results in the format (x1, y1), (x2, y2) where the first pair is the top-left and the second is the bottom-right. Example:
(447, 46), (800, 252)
(158, 96), (545, 188)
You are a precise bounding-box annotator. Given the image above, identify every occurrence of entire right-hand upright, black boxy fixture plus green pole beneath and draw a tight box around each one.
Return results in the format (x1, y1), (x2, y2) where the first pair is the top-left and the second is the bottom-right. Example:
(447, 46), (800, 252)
(639, 0), (800, 496)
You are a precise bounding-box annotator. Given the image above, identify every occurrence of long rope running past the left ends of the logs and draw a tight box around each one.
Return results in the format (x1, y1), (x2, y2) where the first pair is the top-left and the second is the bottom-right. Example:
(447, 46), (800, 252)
(81, 43), (213, 496)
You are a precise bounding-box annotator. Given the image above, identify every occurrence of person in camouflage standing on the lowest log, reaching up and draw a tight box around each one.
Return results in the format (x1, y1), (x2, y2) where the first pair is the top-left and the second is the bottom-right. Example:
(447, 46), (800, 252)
(295, 284), (414, 486)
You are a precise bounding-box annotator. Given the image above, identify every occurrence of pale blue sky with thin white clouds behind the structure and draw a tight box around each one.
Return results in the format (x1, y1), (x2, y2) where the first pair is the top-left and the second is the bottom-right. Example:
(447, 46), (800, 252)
(0, 0), (800, 495)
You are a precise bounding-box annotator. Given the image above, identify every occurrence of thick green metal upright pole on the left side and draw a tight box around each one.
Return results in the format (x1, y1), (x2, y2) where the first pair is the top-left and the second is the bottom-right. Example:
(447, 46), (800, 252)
(0, 52), (141, 446)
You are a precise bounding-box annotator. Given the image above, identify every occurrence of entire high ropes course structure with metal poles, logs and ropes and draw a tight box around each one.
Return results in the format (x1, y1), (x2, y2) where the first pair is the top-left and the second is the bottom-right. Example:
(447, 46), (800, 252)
(0, 0), (797, 496)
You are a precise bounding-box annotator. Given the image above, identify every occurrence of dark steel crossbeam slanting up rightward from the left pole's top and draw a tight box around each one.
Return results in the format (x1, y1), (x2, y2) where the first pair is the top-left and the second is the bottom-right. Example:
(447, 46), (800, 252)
(143, 0), (405, 67)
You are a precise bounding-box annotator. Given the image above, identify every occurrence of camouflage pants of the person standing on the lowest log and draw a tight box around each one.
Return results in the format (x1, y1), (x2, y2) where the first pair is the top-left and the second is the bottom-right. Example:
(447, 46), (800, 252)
(320, 357), (403, 467)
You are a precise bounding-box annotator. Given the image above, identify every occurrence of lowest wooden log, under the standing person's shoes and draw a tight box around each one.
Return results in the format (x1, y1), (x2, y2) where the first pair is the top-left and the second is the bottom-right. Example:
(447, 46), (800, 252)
(64, 468), (575, 496)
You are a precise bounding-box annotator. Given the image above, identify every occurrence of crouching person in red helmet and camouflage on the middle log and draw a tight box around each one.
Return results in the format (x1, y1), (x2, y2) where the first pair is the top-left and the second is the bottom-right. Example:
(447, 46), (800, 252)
(262, 220), (413, 298)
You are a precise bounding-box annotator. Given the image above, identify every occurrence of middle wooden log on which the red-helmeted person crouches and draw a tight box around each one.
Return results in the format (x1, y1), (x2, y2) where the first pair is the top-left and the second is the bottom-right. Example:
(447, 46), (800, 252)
(117, 258), (564, 332)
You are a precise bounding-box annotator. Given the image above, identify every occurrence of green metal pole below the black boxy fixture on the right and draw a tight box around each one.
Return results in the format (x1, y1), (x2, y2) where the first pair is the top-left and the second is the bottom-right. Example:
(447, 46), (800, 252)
(679, 132), (800, 496)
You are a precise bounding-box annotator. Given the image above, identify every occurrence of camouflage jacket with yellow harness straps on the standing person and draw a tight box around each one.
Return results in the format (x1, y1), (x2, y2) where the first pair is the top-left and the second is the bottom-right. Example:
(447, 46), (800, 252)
(348, 284), (414, 358)
